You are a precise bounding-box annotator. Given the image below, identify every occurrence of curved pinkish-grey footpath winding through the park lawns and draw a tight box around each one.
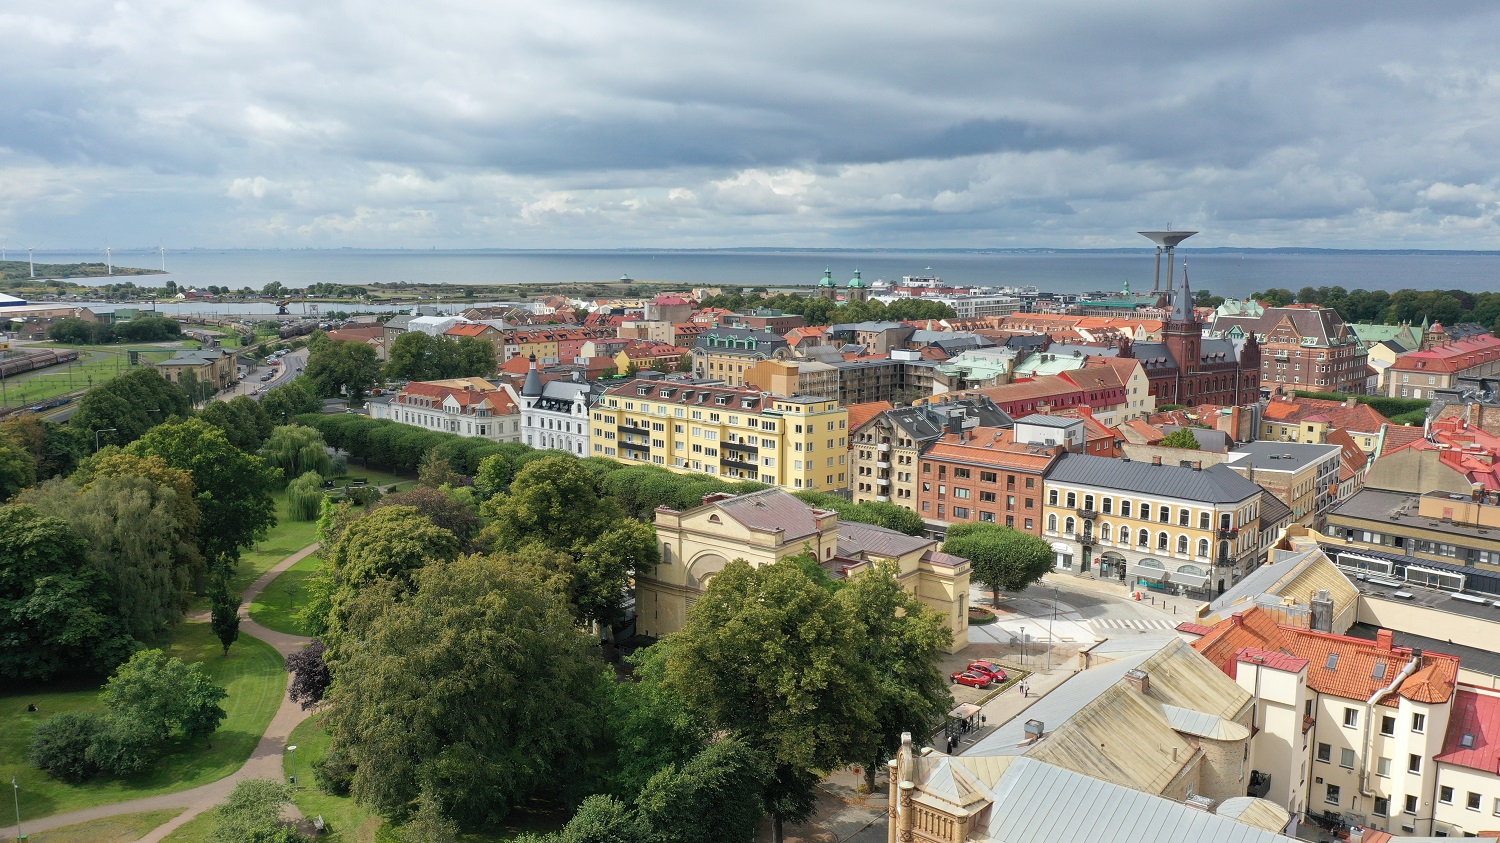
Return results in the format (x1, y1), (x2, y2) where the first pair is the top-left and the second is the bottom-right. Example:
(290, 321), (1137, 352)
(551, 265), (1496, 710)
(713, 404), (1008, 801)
(0, 545), (318, 843)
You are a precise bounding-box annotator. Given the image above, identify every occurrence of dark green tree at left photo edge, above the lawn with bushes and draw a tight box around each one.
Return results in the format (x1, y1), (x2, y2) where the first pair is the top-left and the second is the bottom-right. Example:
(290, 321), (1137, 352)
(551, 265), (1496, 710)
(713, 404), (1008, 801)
(0, 504), (137, 681)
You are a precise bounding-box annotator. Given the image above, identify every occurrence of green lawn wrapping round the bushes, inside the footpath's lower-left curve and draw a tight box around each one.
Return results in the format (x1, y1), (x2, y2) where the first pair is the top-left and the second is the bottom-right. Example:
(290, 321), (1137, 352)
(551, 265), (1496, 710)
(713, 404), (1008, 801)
(0, 623), (287, 818)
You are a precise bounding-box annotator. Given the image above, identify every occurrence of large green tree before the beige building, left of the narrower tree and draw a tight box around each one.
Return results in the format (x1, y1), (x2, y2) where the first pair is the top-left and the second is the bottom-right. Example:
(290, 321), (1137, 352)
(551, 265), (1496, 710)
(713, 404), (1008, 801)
(666, 560), (876, 843)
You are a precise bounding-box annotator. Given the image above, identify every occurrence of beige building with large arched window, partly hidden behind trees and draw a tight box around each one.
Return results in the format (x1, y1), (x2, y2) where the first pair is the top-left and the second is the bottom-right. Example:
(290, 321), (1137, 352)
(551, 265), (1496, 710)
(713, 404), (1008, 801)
(636, 489), (969, 653)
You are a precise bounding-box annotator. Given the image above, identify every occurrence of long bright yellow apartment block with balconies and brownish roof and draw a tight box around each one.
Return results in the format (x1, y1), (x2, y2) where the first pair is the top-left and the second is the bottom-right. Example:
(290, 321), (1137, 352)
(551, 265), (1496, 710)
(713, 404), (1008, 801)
(590, 377), (849, 492)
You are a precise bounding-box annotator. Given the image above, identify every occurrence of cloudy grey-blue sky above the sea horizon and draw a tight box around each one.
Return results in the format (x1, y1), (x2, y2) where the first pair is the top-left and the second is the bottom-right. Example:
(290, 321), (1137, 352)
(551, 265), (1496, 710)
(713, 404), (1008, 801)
(0, 0), (1500, 249)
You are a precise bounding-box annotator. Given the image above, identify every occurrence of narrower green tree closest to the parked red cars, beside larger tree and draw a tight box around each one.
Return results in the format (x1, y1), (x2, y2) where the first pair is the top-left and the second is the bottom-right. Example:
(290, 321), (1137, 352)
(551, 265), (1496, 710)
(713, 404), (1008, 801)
(834, 563), (953, 792)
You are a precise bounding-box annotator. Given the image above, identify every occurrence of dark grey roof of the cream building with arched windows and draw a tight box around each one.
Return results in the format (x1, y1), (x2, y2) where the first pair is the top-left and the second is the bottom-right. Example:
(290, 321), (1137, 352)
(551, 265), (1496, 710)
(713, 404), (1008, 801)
(1047, 453), (1262, 504)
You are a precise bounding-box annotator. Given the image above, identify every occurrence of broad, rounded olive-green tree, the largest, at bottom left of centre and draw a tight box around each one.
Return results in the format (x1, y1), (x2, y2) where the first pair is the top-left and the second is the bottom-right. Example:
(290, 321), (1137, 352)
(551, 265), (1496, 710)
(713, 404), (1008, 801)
(324, 557), (603, 827)
